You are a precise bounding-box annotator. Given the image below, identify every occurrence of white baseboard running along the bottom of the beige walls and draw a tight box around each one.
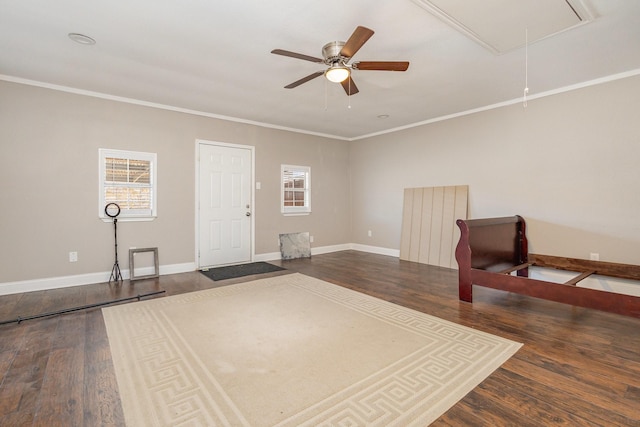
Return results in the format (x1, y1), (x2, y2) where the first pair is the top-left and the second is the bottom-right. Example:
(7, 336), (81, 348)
(0, 243), (400, 295)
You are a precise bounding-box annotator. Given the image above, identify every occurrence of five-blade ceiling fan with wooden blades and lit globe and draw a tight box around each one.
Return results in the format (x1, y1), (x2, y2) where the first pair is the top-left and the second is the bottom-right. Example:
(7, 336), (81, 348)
(271, 26), (409, 96)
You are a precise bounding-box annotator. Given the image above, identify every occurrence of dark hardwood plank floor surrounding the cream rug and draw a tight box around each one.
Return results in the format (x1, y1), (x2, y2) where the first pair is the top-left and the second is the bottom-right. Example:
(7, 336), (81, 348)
(0, 251), (640, 427)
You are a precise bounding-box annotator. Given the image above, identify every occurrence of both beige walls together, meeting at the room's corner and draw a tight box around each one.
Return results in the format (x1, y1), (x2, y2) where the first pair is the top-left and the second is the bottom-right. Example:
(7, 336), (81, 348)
(0, 76), (640, 284)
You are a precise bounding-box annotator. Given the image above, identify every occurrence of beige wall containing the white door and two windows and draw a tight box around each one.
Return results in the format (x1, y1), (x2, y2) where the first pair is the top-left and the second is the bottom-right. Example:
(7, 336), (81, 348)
(0, 81), (350, 284)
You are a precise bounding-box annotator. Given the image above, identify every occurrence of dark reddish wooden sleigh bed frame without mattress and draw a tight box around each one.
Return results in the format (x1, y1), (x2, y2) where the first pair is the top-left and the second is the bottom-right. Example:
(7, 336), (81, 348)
(456, 215), (640, 318)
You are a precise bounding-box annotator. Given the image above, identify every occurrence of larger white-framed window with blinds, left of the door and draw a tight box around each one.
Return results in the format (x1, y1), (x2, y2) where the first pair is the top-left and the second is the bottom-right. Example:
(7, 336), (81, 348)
(98, 148), (157, 220)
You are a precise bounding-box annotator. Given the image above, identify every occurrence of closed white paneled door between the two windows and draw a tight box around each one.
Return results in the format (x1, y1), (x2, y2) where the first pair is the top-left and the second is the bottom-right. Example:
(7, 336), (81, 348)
(196, 143), (253, 268)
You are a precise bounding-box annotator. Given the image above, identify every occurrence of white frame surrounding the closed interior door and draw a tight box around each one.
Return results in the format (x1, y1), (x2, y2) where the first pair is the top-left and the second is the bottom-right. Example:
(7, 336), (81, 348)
(194, 139), (256, 270)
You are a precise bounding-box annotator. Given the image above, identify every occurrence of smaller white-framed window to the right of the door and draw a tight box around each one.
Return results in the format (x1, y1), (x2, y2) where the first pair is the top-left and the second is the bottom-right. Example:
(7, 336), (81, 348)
(281, 165), (311, 215)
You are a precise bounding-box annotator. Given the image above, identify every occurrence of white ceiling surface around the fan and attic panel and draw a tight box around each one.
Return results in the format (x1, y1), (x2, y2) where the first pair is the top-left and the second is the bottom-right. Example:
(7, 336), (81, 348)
(0, 0), (640, 139)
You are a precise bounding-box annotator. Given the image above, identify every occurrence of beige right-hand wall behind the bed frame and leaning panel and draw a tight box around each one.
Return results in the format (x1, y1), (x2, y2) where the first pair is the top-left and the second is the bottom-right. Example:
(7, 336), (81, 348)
(350, 76), (640, 264)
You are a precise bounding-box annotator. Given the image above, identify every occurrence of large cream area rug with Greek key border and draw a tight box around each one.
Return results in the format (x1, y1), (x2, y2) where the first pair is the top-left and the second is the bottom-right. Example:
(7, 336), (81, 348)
(102, 273), (521, 427)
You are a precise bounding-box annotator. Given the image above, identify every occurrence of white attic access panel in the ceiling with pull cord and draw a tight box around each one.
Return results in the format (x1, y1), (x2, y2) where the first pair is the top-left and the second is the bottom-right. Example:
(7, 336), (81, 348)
(413, 0), (594, 54)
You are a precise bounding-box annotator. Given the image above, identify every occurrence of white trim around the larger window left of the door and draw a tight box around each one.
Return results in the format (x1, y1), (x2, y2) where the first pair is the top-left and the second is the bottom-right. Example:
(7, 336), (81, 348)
(98, 148), (158, 222)
